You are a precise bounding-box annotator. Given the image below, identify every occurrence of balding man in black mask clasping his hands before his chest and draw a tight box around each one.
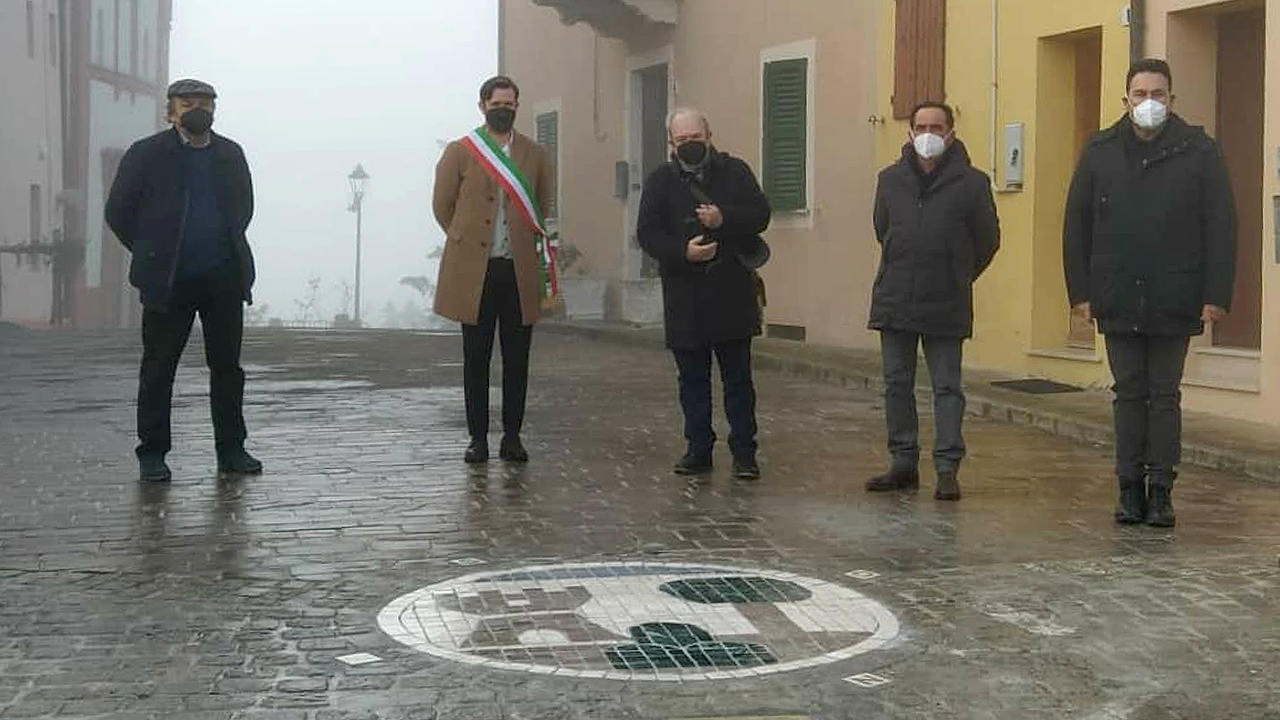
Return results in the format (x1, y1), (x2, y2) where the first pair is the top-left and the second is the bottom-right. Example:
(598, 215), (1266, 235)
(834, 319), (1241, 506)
(636, 109), (771, 478)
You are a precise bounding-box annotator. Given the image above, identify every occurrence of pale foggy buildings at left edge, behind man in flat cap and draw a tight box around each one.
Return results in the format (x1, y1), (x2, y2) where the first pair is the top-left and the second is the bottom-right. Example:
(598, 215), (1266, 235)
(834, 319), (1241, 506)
(0, 0), (173, 328)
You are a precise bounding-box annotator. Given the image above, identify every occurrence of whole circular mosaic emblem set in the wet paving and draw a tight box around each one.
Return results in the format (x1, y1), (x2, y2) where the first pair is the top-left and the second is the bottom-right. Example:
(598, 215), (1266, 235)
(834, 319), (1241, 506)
(378, 562), (899, 680)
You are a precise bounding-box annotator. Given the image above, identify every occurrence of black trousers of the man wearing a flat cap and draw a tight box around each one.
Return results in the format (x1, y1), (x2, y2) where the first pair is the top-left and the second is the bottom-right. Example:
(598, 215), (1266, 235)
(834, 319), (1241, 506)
(137, 265), (247, 457)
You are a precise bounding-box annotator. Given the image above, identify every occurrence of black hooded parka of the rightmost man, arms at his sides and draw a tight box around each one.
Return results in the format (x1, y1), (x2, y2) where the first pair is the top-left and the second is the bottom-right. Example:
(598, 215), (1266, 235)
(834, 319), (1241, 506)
(1062, 115), (1236, 336)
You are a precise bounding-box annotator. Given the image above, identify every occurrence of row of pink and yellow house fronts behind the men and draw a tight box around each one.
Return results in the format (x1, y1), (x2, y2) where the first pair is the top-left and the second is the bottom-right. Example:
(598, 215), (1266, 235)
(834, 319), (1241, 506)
(499, 0), (1280, 428)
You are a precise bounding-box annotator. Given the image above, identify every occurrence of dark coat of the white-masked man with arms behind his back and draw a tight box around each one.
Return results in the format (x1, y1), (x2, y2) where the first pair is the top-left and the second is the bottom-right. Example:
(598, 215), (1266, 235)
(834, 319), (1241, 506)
(869, 140), (1000, 338)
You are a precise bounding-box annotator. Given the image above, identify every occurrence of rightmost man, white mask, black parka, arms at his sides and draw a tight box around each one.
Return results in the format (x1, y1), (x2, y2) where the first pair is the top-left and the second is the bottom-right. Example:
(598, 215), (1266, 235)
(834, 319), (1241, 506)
(1062, 60), (1236, 527)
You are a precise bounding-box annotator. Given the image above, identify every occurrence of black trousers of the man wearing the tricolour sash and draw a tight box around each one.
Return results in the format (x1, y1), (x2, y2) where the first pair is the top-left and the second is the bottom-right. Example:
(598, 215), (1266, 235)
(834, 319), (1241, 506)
(462, 259), (534, 441)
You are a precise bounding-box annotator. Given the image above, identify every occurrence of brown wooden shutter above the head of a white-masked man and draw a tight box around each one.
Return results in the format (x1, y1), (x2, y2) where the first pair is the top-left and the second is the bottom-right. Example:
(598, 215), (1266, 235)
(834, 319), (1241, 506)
(893, 0), (947, 120)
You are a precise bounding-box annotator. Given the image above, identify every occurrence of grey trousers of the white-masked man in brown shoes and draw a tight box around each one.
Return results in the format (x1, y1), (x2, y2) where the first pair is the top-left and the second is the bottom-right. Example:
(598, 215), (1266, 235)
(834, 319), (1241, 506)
(881, 329), (965, 473)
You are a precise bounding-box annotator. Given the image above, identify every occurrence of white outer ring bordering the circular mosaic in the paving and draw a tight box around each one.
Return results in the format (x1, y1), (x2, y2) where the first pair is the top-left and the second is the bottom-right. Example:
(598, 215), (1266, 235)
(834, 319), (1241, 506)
(378, 562), (901, 682)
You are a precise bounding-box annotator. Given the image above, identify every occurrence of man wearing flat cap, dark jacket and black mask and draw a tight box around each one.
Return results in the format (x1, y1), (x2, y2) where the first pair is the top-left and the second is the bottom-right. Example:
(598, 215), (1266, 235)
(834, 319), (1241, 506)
(106, 79), (262, 482)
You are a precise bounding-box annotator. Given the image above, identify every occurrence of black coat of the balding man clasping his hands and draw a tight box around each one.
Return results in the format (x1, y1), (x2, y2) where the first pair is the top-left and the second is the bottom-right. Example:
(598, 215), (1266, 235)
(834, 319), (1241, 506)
(636, 151), (771, 348)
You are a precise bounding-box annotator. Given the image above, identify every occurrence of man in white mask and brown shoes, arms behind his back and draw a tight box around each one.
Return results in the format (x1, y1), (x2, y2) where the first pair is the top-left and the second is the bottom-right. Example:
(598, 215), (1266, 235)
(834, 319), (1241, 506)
(867, 102), (1000, 501)
